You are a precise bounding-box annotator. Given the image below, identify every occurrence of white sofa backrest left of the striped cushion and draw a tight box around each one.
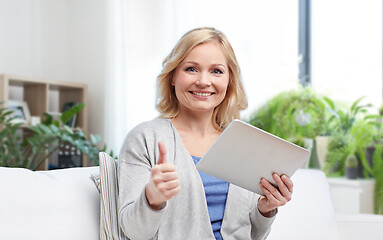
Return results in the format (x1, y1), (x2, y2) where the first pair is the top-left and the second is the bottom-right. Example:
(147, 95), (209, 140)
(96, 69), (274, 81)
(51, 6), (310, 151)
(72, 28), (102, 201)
(0, 167), (100, 240)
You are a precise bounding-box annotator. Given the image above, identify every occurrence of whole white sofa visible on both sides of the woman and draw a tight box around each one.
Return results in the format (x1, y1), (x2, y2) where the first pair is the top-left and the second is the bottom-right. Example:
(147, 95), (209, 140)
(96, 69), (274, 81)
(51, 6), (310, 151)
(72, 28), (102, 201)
(0, 167), (383, 240)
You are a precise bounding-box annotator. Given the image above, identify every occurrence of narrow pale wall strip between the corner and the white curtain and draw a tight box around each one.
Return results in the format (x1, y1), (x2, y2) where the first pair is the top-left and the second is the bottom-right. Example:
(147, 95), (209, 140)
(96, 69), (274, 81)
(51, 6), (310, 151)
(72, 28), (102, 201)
(67, 0), (108, 139)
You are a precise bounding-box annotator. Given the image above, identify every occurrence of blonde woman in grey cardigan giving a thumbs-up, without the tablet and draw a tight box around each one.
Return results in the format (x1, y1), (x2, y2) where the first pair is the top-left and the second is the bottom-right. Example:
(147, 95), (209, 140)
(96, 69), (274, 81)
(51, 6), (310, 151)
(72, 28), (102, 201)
(119, 28), (293, 240)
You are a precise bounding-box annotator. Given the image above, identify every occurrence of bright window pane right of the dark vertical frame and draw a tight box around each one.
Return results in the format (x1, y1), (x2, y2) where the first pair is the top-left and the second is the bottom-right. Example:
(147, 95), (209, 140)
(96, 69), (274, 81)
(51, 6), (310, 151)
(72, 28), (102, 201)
(311, 0), (382, 107)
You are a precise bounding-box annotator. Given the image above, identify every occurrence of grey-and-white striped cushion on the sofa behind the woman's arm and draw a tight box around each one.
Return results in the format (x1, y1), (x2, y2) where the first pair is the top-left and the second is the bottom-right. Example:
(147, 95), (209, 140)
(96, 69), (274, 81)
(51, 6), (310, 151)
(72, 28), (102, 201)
(99, 152), (128, 240)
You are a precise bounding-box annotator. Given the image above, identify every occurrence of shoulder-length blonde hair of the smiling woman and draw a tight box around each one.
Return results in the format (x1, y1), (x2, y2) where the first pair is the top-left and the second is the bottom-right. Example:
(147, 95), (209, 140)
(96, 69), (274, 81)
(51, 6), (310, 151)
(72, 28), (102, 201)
(156, 27), (247, 130)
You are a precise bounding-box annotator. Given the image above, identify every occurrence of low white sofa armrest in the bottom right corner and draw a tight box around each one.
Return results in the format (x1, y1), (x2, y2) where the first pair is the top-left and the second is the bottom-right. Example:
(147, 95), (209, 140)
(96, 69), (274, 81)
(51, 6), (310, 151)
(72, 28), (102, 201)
(335, 213), (383, 240)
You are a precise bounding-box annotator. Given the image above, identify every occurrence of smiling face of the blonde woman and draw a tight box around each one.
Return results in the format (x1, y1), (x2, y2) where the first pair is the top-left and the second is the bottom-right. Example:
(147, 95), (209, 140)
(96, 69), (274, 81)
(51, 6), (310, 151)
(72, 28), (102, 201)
(172, 41), (229, 116)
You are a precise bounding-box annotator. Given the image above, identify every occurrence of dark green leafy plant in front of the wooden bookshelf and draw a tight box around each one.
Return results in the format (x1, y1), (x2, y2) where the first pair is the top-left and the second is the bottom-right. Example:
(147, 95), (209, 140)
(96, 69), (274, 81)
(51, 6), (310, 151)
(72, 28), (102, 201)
(0, 104), (113, 170)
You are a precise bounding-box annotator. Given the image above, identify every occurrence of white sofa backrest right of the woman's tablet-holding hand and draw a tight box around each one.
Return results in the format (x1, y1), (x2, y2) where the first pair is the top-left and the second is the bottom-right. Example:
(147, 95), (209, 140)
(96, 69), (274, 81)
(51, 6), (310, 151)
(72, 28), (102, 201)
(267, 169), (339, 240)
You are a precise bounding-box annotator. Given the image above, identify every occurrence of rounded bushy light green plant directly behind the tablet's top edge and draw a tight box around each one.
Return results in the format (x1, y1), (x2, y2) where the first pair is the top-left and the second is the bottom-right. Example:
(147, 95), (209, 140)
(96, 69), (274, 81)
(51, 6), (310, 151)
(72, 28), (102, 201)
(248, 88), (325, 146)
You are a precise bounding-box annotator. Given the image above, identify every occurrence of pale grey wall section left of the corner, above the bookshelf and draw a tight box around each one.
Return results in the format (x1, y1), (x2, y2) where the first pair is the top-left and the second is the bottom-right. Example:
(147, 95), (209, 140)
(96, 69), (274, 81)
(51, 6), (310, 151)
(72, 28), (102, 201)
(0, 0), (68, 80)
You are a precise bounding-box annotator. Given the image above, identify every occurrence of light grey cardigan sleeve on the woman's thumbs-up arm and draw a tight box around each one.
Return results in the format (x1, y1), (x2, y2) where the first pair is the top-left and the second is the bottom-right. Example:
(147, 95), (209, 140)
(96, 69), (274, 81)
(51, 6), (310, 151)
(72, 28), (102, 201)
(118, 123), (166, 239)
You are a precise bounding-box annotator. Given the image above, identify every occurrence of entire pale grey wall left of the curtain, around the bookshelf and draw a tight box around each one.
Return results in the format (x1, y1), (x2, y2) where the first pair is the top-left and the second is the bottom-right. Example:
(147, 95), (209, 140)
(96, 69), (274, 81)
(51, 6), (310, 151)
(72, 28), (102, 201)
(0, 0), (107, 142)
